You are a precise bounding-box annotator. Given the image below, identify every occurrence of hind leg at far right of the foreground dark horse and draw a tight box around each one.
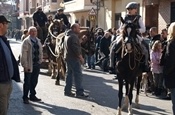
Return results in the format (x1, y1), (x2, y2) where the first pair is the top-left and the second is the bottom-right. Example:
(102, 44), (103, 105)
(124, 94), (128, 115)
(135, 74), (142, 109)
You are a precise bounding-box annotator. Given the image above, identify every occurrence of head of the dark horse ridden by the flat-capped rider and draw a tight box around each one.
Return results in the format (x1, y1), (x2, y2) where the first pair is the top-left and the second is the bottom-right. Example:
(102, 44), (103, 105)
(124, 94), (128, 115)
(121, 17), (138, 51)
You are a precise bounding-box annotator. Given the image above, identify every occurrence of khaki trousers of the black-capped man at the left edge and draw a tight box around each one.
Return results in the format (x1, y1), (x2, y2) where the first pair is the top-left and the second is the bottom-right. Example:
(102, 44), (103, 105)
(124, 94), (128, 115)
(0, 82), (12, 115)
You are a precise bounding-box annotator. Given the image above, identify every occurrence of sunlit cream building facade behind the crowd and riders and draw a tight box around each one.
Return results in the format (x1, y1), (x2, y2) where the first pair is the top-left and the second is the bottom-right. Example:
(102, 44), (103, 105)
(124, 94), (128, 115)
(19, 0), (175, 32)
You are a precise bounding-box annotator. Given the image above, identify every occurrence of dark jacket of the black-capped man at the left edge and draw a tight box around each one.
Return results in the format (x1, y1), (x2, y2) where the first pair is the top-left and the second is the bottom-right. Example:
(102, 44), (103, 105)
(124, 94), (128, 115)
(0, 36), (20, 83)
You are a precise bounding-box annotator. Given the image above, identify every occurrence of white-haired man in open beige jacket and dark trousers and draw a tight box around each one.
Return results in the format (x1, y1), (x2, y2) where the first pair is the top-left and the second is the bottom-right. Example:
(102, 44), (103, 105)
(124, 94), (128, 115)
(21, 26), (43, 104)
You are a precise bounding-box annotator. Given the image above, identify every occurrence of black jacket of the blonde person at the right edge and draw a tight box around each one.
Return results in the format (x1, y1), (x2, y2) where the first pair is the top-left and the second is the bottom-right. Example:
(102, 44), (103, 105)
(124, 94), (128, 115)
(163, 40), (175, 88)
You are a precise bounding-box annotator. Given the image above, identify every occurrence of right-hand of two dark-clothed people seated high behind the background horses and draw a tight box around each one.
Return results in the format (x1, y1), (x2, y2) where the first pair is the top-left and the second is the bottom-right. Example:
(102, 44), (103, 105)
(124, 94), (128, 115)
(54, 8), (70, 28)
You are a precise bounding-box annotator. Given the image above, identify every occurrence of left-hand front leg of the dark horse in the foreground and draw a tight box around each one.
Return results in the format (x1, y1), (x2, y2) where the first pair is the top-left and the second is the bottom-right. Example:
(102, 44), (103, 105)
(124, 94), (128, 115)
(117, 74), (123, 115)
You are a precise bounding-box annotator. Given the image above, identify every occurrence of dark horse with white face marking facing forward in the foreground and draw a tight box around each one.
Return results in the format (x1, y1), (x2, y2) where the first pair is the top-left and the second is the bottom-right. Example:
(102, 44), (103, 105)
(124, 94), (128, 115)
(116, 17), (145, 115)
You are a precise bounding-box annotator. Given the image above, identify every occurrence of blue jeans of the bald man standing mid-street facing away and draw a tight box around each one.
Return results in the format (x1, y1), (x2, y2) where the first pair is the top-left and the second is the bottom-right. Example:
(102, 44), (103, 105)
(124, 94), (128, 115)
(64, 59), (84, 95)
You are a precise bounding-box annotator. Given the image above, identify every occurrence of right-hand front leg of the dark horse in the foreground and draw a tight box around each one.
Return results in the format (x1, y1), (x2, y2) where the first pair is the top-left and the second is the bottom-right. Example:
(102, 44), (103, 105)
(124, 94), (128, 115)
(128, 80), (135, 115)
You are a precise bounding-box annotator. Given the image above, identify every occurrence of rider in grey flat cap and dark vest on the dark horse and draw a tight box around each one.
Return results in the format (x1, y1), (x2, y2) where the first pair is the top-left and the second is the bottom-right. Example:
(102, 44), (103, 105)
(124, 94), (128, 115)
(110, 2), (148, 71)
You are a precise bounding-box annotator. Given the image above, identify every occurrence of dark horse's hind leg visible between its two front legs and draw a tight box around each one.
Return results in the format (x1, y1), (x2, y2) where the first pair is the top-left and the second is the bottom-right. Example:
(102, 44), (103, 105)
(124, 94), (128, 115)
(122, 80), (129, 110)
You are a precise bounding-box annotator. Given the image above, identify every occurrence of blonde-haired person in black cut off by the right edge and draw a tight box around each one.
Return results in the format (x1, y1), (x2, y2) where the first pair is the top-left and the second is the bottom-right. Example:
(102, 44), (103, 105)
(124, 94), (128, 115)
(163, 22), (175, 115)
